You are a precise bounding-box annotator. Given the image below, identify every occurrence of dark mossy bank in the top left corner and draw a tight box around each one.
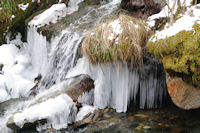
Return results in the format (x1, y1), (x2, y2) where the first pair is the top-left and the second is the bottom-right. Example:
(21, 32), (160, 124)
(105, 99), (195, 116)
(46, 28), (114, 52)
(0, 0), (56, 45)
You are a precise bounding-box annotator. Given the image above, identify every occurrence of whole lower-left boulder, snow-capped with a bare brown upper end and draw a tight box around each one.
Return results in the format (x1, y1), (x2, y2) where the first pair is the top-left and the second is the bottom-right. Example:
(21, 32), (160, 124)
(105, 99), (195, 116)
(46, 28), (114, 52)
(7, 75), (94, 132)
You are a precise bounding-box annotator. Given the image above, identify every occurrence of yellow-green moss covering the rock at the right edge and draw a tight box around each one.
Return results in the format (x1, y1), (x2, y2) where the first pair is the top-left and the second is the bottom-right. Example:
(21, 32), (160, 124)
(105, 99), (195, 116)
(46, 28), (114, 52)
(147, 24), (200, 86)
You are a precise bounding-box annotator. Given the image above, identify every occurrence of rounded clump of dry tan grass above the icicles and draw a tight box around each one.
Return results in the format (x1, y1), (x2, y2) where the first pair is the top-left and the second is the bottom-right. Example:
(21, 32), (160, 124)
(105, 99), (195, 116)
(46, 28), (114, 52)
(82, 15), (148, 66)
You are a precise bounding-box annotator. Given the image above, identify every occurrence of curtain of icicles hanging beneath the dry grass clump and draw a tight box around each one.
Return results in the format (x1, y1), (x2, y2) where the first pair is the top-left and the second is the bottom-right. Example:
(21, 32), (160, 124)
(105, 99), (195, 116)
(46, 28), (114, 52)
(67, 57), (167, 112)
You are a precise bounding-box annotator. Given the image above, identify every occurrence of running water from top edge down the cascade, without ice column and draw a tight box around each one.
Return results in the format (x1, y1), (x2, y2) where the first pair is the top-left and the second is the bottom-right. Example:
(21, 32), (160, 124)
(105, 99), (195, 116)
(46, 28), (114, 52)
(34, 0), (120, 88)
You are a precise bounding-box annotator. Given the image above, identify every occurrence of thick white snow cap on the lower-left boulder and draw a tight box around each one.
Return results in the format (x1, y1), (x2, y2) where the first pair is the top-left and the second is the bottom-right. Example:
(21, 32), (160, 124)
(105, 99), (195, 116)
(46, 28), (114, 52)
(14, 94), (77, 129)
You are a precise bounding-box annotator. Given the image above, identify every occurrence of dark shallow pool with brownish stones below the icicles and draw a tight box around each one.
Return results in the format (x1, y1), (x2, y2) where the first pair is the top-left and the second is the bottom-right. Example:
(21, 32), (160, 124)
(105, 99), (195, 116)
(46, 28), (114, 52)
(75, 105), (200, 133)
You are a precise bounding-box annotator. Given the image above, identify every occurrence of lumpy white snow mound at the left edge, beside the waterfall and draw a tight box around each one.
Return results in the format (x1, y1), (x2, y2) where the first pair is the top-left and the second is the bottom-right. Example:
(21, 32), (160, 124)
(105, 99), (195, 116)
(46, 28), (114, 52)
(0, 44), (35, 102)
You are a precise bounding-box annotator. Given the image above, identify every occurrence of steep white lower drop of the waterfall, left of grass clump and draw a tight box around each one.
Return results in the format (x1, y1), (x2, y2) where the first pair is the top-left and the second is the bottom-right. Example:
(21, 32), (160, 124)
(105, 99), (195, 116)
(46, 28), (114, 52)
(41, 31), (82, 88)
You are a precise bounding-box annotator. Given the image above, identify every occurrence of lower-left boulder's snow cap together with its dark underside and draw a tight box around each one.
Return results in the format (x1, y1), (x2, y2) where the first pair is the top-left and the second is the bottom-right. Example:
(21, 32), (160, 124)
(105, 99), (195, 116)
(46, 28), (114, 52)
(7, 94), (77, 132)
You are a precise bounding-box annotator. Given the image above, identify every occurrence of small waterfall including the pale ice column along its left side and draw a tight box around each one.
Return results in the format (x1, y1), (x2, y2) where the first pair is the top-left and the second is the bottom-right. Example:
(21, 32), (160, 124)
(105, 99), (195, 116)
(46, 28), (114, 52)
(33, 0), (120, 89)
